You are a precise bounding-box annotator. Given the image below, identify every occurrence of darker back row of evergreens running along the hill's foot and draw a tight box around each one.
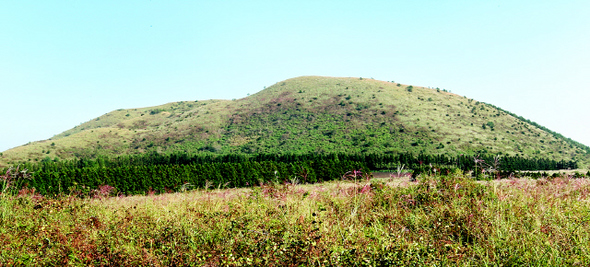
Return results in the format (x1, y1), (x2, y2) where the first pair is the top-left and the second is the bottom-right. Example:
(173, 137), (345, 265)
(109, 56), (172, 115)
(25, 153), (578, 171)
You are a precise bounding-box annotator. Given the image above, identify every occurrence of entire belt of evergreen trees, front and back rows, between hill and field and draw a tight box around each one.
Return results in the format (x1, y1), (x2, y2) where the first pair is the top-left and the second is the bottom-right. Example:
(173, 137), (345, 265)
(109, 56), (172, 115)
(3, 153), (578, 195)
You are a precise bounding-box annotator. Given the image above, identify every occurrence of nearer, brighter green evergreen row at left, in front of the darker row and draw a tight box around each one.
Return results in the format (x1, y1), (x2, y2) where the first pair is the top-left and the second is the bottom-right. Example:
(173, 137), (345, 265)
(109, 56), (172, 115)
(22, 160), (370, 195)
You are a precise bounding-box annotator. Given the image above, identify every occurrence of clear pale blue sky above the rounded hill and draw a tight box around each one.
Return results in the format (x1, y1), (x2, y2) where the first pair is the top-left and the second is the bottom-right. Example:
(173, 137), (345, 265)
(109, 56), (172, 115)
(0, 0), (590, 151)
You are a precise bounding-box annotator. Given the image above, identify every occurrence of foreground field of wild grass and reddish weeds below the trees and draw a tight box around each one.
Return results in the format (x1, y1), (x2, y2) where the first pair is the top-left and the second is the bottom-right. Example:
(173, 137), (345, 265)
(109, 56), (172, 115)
(0, 173), (590, 266)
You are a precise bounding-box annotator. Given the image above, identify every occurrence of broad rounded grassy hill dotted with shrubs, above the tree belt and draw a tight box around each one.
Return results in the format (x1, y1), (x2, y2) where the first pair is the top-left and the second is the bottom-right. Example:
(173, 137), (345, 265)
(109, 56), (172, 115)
(0, 76), (590, 166)
